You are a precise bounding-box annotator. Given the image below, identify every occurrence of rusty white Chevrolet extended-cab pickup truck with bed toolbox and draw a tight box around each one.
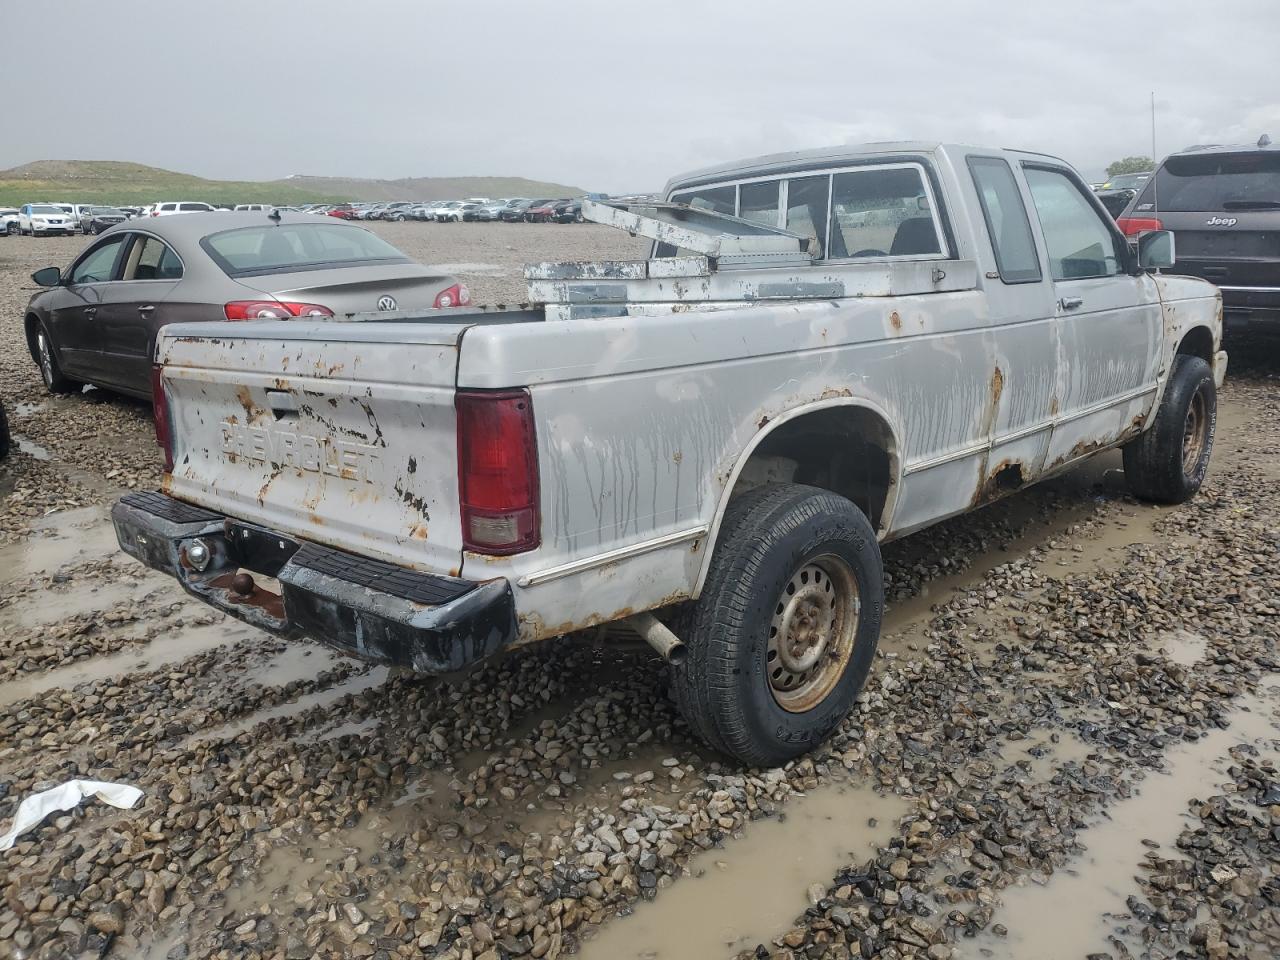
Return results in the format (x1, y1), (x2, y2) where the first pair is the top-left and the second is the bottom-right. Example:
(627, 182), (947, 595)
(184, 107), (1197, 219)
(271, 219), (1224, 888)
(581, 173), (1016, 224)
(114, 143), (1226, 764)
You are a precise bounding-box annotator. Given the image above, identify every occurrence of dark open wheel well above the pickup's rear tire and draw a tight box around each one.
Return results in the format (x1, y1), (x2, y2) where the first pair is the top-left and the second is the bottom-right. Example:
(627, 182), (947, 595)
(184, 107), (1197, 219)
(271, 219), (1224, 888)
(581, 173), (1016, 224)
(731, 406), (897, 535)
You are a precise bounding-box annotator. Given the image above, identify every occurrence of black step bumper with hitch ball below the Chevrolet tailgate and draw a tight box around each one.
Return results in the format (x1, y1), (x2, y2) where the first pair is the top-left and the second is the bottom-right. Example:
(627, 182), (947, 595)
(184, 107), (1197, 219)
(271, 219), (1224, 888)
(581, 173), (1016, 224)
(111, 493), (517, 673)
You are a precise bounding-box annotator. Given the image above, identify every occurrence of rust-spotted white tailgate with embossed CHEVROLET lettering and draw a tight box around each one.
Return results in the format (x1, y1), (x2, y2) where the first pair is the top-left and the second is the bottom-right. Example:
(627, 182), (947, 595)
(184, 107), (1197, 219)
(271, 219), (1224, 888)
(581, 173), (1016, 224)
(156, 320), (467, 573)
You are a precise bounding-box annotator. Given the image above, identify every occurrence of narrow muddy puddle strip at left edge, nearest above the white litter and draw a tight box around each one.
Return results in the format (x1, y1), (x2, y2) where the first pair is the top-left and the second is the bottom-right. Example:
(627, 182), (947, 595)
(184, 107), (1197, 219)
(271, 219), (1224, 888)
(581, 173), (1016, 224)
(0, 621), (257, 707)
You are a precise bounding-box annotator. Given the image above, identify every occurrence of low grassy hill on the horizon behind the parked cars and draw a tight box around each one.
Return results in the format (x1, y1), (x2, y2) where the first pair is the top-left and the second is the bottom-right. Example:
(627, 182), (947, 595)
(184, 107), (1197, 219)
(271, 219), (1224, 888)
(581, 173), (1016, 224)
(0, 160), (582, 206)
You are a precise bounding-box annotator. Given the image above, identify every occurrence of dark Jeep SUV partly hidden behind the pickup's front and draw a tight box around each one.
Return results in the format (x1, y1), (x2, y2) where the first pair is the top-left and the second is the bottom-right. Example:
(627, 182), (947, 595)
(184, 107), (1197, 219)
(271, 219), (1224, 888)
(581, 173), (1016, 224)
(1117, 136), (1280, 323)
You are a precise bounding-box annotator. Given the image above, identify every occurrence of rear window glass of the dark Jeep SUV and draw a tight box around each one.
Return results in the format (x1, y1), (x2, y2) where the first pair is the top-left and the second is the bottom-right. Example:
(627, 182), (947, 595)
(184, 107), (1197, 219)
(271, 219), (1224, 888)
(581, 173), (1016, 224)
(1135, 151), (1280, 212)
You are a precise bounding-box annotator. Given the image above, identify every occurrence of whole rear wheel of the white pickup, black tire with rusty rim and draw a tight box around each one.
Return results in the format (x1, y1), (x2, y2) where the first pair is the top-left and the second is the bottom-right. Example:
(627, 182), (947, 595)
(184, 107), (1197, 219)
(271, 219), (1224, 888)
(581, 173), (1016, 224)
(672, 484), (884, 767)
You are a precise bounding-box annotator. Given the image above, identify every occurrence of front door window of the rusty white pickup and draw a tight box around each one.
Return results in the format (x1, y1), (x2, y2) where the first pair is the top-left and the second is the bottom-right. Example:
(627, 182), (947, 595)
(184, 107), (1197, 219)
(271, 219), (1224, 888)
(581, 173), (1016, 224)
(1024, 166), (1124, 280)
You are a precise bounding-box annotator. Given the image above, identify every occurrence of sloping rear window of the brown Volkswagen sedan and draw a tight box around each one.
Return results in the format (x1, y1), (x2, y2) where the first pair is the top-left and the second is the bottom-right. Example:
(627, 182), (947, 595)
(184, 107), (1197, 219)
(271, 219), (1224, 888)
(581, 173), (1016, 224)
(200, 223), (410, 276)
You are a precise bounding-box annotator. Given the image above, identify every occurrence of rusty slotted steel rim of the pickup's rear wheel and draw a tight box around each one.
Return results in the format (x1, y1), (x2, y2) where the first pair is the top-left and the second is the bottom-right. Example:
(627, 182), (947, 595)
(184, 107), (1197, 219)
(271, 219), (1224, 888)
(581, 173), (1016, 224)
(764, 554), (861, 713)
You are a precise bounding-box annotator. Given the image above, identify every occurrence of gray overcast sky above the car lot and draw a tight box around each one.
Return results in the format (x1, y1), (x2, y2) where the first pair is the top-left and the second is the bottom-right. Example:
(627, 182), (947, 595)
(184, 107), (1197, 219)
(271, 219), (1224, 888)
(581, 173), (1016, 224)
(0, 0), (1280, 191)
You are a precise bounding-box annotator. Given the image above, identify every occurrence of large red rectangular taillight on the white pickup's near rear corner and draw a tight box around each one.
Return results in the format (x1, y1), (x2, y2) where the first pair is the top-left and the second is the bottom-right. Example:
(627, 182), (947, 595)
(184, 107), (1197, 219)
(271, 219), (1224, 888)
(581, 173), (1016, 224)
(456, 390), (541, 556)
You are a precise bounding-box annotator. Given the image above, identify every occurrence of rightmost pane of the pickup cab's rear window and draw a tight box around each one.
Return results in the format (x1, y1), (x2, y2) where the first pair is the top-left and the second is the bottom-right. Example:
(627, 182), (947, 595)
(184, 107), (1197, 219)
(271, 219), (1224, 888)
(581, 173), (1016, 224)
(828, 164), (942, 260)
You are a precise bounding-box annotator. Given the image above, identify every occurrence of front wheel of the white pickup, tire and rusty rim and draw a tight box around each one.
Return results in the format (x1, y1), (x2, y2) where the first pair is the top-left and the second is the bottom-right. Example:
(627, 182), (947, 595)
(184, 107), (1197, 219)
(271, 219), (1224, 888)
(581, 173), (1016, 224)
(1124, 353), (1217, 503)
